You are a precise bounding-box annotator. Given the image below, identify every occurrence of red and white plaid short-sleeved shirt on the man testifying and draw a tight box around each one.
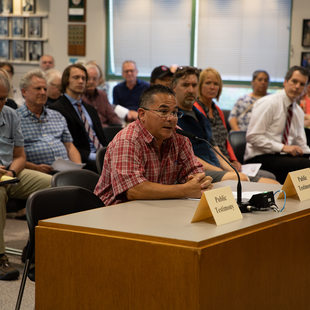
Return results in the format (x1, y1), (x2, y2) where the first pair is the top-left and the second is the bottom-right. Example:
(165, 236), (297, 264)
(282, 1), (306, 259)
(95, 120), (203, 206)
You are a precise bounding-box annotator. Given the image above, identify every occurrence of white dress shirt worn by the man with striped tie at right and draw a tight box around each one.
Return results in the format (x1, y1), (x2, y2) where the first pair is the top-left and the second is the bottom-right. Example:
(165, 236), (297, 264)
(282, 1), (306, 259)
(244, 89), (310, 160)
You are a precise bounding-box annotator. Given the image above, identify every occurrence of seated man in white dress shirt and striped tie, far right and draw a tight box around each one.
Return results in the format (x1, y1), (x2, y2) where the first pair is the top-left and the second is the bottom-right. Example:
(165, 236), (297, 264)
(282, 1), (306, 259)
(244, 66), (310, 183)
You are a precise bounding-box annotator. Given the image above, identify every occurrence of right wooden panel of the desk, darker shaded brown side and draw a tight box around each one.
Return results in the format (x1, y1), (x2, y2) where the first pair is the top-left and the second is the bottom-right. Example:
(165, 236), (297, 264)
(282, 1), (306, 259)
(200, 214), (310, 310)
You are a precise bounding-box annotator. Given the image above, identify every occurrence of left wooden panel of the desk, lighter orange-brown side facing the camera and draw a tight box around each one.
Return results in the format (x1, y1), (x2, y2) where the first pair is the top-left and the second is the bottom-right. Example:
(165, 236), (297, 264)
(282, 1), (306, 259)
(36, 226), (199, 310)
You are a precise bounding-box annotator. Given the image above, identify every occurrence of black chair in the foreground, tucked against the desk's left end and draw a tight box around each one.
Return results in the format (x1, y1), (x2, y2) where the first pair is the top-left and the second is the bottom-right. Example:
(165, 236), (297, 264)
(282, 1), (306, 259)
(15, 186), (103, 310)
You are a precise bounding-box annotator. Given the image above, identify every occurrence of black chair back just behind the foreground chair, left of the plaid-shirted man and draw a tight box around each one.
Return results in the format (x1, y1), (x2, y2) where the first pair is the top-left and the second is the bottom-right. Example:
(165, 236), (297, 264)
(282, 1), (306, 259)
(51, 169), (100, 191)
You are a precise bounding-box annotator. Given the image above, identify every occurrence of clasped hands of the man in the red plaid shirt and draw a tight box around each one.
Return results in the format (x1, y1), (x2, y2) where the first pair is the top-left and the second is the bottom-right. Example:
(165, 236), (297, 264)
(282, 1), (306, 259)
(185, 173), (213, 198)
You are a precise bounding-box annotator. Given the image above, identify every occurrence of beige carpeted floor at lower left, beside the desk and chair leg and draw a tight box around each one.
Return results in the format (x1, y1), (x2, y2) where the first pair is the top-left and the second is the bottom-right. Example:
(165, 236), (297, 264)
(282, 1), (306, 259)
(0, 218), (35, 310)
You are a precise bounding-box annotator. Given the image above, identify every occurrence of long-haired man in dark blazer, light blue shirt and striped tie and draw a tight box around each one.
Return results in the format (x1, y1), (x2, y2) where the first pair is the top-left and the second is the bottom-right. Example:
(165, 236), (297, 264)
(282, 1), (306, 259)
(49, 64), (107, 172)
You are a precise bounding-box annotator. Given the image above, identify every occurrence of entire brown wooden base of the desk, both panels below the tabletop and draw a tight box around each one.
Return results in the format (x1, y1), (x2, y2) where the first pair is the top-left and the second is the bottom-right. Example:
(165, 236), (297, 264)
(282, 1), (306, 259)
(36, 209), (310, 310)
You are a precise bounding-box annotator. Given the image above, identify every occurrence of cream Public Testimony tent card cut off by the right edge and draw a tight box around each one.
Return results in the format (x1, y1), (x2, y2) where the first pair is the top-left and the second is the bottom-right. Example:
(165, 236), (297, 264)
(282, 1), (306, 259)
(278, 168), (310, 201)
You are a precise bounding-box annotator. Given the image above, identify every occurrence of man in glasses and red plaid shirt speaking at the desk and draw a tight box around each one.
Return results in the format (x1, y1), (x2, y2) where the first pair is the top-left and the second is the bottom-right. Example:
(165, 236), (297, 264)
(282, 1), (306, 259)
(95, 85), (212, 205)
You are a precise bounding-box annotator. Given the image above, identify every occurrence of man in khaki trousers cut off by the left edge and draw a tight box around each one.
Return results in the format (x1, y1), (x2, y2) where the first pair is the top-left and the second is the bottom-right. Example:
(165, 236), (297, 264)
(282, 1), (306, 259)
(0, 74), (51, 280)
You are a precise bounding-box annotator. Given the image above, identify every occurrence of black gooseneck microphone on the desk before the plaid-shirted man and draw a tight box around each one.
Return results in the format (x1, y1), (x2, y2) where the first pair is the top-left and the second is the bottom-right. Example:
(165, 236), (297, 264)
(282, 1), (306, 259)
(175, 128), (251, 213)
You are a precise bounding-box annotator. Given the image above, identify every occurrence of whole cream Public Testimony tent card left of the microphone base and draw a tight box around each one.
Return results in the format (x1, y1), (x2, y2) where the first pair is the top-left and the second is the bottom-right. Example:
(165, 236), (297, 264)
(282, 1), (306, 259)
(191, 186), (242, 225)
